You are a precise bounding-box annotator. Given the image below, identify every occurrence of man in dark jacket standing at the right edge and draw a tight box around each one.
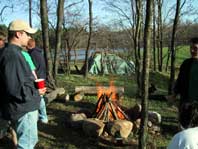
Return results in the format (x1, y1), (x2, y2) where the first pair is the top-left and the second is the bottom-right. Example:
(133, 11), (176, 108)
(169, 38), (198, 128)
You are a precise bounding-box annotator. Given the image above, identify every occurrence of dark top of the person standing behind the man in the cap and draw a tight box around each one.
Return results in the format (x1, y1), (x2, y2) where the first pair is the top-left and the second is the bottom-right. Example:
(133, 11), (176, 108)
(28, 48), (46, 79)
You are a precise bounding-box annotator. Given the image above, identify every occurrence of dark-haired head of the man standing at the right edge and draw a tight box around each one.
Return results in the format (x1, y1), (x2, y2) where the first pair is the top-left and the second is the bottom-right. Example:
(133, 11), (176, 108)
(190, 37), (198, 59)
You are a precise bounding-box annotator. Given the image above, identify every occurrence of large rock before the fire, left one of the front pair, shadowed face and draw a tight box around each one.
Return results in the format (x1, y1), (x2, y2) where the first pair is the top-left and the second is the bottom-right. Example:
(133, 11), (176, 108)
(82, 118), (105, 137)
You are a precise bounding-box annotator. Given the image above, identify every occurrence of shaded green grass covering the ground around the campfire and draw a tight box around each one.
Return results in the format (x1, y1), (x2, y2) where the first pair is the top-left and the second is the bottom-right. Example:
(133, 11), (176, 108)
(36, 46), (190, 149)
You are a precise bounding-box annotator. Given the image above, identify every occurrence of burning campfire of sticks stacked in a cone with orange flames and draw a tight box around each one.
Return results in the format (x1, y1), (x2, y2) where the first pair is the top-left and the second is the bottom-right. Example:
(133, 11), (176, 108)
(94, 82), (129, 122)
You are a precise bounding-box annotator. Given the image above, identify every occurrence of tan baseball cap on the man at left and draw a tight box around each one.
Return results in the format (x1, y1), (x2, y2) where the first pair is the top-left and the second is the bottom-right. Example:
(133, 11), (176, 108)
(8, 19), (37, 34)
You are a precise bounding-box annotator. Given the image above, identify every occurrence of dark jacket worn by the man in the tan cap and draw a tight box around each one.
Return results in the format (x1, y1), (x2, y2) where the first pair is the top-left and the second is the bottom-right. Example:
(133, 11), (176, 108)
(0, 44), (40, 120)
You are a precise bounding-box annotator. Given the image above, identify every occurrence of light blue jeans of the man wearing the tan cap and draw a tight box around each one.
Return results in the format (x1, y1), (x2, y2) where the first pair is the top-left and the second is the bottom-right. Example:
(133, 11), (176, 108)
(12, 110), (38, 149)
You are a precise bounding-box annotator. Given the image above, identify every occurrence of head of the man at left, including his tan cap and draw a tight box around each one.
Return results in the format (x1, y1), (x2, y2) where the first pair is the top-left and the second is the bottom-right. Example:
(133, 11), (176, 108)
(8, 20), (37, 47)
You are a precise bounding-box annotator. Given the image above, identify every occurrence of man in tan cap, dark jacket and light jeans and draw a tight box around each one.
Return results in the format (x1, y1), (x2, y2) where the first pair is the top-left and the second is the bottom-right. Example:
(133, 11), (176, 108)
(0, 20), (46, 149)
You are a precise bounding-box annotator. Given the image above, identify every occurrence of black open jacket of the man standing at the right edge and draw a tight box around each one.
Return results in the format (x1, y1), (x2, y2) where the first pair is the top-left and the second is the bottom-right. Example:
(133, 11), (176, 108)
(174, 58), (194, 104)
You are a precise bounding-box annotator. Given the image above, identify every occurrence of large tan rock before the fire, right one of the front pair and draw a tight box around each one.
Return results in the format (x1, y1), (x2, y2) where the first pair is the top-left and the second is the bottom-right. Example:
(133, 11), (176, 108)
(107, 120), (133, 139)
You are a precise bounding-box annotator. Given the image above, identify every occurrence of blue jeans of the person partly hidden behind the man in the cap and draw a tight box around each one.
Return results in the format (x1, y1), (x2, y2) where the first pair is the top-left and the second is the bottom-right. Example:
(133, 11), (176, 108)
(39, 96), (48, 123)
